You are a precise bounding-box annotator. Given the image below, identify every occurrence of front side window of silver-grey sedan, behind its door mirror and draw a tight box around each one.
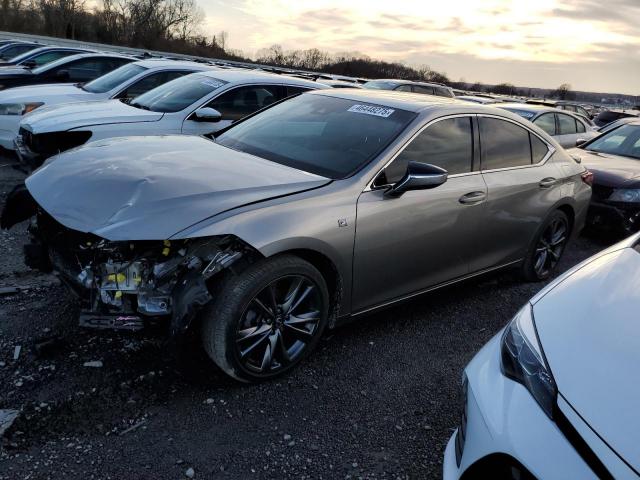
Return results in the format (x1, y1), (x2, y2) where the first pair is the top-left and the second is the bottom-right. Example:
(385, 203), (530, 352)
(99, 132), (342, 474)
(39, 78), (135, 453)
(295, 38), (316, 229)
(376, 117), (473, 184)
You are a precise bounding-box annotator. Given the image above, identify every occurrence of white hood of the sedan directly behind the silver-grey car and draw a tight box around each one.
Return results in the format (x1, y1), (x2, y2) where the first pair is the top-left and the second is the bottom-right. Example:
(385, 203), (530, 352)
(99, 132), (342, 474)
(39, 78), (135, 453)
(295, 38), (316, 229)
(20, 100), (163, 133)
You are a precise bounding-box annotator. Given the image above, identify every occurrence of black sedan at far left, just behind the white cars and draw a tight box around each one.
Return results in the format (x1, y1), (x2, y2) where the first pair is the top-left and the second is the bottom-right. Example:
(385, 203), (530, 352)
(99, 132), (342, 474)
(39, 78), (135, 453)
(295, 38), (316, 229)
(0, 53), (135, 90)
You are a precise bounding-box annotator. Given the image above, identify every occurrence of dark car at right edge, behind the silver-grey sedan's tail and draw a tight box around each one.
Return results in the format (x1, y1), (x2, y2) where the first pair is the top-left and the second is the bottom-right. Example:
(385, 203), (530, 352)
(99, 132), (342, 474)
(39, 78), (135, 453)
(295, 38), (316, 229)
(570, 120), (640, 235)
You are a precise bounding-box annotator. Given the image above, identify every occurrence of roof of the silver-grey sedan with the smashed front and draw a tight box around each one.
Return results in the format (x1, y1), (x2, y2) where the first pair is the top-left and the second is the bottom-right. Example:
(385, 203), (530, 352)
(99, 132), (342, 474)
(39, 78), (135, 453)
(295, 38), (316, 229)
(305, 88), (476, 113)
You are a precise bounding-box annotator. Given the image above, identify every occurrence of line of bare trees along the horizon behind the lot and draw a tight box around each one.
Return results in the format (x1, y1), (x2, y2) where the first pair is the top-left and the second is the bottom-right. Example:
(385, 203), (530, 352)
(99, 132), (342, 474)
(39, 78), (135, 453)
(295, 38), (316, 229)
(0, 0), (449, 83)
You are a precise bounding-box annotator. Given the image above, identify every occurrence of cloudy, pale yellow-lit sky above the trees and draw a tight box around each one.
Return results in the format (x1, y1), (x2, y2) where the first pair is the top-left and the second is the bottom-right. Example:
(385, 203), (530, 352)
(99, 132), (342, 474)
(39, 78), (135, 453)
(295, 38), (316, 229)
(199, 0), (640, 95)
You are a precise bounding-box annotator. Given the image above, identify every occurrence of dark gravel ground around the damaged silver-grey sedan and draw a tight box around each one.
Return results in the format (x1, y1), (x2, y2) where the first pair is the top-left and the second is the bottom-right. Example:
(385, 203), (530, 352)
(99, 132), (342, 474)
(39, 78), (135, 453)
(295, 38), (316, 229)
(0, 156), (606, 480)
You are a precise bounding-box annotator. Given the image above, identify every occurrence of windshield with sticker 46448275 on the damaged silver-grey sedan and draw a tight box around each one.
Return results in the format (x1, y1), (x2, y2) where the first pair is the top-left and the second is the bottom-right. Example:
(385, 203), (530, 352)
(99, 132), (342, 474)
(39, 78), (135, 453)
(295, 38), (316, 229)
(216, 94), (416, 179)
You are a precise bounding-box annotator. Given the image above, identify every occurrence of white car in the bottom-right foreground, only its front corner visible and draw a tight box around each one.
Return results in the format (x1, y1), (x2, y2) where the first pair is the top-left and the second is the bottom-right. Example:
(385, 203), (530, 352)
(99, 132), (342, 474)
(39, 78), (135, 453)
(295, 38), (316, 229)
(444, 235), (640, 480)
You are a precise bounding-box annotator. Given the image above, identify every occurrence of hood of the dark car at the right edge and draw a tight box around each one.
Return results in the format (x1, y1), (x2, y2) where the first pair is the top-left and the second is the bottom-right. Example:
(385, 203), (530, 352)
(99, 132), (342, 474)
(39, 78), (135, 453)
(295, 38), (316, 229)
(569, 148), (640, 188)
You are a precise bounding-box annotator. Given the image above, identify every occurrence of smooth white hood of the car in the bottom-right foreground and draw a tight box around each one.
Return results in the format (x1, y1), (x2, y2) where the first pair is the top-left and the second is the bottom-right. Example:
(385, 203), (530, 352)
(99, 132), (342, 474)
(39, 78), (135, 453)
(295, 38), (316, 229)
(533, 248), (640, 470)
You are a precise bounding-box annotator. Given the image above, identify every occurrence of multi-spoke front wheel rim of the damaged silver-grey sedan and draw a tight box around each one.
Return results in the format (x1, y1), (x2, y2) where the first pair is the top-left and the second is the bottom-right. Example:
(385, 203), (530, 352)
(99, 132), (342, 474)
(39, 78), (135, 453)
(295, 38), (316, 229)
(236, 275), (322, 375)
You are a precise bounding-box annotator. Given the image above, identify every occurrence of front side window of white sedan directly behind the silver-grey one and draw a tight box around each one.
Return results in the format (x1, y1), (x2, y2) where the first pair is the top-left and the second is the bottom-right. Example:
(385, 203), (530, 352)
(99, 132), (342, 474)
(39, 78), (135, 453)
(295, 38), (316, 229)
(207, 85), (280, 121)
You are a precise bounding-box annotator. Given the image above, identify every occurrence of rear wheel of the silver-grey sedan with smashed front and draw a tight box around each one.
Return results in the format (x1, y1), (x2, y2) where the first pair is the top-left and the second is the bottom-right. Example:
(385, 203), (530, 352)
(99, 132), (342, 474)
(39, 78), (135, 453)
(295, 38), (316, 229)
(521, 210), (571, 282)
